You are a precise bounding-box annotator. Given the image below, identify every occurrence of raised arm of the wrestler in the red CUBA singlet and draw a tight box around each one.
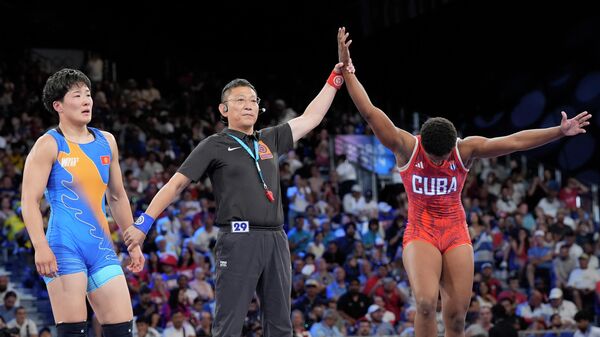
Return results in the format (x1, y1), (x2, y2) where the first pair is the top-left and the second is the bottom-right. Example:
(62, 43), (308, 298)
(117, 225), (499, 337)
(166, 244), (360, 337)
(338, 28), (415, 160)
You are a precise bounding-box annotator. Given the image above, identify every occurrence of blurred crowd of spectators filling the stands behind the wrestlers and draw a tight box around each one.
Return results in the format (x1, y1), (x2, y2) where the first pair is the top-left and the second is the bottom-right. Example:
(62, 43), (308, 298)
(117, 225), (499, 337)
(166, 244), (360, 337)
(0, 50), (600, 337)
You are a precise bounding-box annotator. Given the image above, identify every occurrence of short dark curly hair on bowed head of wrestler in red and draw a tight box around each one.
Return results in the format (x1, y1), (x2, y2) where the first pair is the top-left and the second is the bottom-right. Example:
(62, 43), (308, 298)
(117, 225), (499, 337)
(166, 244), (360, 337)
(421, 117), (458, 157)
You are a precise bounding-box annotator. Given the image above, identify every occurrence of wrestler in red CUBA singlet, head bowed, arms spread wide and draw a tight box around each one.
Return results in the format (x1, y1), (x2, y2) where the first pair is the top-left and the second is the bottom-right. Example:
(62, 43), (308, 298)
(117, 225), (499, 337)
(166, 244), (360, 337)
(338, 28), (591, 337)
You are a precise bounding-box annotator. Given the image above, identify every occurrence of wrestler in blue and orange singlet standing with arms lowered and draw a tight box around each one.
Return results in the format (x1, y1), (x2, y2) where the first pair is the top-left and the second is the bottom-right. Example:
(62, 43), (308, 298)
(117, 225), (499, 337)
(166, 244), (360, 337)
(22, 69), (144, 337)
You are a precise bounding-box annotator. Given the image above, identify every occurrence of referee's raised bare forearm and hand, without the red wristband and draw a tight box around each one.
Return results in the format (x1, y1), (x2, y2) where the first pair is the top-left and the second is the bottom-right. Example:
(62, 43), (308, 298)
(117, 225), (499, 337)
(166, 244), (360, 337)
(289, 63), (342, 142)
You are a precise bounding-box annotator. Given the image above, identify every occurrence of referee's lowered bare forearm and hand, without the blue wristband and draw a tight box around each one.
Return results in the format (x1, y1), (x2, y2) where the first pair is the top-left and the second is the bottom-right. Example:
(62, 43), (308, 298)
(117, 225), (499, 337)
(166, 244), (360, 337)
(123, 172), (191, 247)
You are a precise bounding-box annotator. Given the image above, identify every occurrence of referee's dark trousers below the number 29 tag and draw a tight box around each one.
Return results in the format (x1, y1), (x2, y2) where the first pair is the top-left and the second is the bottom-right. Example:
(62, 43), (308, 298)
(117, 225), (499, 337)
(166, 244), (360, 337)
(212, 228), (292, 337)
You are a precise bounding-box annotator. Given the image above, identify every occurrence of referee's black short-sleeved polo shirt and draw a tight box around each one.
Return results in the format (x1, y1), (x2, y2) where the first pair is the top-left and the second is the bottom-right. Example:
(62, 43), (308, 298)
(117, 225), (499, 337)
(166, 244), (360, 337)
(178, 123), (293, 230)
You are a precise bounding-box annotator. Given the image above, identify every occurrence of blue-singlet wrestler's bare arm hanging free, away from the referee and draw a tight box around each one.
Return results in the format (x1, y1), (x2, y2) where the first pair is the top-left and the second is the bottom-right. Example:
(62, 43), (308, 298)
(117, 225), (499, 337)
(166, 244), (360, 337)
(21, 135), (58, 277)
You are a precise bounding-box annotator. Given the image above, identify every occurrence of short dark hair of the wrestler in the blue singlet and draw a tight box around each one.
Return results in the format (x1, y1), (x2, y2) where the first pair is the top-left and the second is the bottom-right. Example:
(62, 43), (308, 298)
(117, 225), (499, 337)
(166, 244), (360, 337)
(42, 68), (92, 112)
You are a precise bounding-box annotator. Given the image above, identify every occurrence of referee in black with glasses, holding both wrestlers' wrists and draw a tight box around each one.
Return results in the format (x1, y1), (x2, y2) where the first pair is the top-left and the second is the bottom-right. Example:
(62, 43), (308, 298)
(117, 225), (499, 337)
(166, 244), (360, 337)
(124, 63), (343, 337)
